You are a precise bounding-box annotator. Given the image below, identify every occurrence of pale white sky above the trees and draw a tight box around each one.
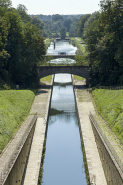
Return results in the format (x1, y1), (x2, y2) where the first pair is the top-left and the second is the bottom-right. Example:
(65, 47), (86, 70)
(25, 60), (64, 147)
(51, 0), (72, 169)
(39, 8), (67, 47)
(11, 0), (100, 15)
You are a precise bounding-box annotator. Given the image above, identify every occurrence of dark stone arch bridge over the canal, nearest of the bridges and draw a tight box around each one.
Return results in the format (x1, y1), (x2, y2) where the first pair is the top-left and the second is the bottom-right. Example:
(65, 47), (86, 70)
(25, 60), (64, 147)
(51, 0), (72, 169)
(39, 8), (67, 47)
(38, 66), (89, 86)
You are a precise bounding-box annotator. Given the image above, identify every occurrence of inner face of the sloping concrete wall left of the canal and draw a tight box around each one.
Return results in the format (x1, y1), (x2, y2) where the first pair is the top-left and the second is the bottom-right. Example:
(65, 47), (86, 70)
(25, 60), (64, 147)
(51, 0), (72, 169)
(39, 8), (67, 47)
(4, 122), (36, 185)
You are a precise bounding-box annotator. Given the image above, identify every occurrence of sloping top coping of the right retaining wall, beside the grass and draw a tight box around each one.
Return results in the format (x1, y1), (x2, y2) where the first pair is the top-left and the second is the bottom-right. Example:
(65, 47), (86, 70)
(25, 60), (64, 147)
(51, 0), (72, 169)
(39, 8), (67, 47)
(89, 112), (123, 172)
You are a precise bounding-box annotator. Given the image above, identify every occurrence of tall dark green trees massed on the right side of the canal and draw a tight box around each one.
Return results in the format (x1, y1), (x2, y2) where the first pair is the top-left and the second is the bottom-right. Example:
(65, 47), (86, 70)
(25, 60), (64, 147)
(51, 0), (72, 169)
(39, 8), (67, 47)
(77, 0), (123, 86)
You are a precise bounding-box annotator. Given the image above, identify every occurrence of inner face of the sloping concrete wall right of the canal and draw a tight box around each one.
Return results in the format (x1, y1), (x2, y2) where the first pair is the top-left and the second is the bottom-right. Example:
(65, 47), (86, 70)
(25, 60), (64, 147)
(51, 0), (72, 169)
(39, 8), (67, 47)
(91, 121), (123, 185)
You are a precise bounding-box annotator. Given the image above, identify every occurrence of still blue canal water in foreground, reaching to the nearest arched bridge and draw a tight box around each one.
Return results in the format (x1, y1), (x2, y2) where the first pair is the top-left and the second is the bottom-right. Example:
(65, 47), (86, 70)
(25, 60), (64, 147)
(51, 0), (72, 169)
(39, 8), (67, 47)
(41, 74), (87, 185)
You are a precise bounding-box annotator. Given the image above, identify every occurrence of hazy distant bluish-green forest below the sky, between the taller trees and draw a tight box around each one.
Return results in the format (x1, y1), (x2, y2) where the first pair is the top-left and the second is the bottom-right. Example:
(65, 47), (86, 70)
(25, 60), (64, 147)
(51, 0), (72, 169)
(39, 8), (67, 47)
(30, 14), (84, 38)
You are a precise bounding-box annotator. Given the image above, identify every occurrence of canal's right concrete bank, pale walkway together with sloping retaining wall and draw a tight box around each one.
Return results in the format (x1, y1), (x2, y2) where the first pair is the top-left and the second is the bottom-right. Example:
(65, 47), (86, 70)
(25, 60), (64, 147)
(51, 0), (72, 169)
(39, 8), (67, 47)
(74, 76), (123, 185)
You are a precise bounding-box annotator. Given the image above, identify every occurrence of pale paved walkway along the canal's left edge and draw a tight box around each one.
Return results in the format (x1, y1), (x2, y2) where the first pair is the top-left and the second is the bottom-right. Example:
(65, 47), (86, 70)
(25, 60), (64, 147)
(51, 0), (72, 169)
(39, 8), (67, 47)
(23, 80), (51, 185)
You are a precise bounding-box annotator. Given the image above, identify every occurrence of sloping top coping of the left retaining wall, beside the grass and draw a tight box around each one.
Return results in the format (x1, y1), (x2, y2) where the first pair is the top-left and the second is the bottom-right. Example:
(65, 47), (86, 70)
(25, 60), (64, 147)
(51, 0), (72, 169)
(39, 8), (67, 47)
(0, 113), (37, 185)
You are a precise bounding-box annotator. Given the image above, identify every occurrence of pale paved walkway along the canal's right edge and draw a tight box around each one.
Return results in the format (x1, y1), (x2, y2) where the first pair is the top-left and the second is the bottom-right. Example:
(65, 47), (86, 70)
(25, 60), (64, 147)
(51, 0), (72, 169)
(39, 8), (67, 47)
(73, 76), (107, 185)
